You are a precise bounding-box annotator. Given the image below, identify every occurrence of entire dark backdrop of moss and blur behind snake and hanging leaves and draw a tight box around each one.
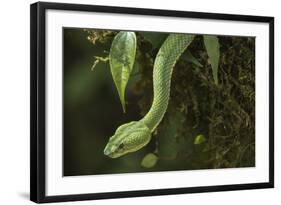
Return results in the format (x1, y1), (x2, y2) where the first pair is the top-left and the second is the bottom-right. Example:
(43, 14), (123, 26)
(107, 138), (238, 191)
(63, 28), (255, 176)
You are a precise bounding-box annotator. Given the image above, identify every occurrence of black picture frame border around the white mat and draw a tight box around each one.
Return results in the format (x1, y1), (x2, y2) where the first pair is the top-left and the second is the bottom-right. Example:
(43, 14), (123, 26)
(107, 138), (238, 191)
(30, 2), (274, 203)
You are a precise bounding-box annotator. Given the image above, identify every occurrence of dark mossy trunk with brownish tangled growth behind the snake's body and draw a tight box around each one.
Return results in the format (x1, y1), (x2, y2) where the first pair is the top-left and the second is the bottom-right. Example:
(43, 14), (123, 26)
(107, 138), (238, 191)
(135, 36), (255, 169)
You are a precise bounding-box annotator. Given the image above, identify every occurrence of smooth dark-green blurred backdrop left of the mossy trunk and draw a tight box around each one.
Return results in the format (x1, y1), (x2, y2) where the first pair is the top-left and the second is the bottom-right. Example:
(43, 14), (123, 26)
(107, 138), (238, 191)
(64, 29), (153, 175)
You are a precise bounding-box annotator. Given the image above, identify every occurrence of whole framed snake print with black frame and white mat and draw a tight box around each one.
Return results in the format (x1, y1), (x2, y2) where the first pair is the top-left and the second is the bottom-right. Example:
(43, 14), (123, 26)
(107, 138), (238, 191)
(30, 2), (274, 203)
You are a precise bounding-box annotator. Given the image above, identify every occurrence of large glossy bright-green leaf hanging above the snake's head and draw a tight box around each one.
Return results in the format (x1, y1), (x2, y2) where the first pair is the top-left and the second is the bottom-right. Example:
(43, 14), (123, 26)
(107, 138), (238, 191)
(109, 31), (137, 112)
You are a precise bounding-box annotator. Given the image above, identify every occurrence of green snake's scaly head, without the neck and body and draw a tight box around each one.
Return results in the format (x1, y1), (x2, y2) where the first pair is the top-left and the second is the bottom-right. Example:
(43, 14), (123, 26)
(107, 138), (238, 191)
(104, 121), (151, 158)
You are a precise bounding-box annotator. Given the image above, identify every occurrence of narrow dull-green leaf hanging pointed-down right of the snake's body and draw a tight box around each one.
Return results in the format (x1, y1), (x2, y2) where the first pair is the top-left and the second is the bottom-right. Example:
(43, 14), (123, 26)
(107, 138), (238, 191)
(204, 35), (220, 84)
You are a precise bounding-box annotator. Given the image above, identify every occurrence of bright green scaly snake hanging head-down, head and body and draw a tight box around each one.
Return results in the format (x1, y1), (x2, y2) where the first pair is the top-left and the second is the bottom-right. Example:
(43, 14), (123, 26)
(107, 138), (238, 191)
(104, 34), (194, 158)
